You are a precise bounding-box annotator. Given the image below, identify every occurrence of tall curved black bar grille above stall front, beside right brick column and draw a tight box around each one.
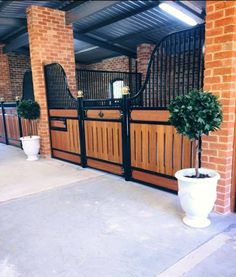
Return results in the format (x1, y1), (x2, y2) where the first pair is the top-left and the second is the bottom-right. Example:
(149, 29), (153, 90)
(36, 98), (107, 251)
(131, 25), (205, 109)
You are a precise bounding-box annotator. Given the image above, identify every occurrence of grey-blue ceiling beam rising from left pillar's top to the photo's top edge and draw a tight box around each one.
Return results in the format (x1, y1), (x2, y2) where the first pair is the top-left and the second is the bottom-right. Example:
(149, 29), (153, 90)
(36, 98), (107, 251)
(66, 1), (121, 24)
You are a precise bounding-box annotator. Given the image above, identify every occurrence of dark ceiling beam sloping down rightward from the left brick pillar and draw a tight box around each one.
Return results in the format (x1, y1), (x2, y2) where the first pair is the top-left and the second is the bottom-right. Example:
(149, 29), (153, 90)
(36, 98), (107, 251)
(74, 34), (136, 58)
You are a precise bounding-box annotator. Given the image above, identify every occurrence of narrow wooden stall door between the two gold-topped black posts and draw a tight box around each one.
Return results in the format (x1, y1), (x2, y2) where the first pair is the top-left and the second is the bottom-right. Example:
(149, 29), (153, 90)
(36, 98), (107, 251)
(85, 110), (123, 175)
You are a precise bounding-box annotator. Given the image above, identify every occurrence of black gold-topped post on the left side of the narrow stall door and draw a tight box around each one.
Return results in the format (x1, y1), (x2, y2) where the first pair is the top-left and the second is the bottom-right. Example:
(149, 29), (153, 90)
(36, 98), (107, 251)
(77, 91), (87, 167)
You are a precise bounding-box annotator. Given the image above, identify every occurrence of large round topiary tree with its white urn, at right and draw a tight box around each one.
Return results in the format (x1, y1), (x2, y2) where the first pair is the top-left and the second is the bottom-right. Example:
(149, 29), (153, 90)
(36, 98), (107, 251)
(168, 91), (222, 228)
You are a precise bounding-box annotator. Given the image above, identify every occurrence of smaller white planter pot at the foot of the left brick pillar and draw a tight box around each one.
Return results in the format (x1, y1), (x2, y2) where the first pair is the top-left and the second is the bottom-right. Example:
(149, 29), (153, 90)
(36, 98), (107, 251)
(20, 136), (40, 161)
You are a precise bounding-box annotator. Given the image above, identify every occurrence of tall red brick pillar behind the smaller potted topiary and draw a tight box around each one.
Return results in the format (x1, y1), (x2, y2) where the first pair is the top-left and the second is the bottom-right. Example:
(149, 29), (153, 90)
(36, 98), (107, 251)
(27, 6), (76, 155)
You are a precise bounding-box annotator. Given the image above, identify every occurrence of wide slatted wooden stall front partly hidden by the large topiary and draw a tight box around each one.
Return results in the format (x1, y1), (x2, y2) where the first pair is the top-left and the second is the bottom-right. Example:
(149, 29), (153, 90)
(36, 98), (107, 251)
(130, 110), (194, 190)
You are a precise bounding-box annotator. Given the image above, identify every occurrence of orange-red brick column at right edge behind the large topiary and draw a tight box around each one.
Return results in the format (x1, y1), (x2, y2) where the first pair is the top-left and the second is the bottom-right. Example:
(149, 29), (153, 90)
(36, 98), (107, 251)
(202, 1), (236, 213)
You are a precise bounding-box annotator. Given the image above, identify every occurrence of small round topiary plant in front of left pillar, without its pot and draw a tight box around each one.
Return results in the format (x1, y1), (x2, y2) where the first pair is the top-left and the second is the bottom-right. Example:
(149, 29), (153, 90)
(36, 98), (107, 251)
(17, 99), (40, 137)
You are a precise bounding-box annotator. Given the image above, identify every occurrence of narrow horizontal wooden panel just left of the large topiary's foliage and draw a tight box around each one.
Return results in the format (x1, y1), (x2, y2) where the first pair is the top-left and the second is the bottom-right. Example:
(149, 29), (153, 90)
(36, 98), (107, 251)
(131, 110), (169, 121)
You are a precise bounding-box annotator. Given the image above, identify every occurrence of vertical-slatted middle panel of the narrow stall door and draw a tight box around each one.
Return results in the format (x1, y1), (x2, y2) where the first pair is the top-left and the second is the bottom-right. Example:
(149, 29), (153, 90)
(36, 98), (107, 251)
(85, 121), (122, 163)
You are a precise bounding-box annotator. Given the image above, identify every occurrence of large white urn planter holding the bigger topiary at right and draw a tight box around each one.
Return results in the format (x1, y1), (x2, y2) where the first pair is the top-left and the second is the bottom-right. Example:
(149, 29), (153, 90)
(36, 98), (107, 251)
(175, 168), (220, 228)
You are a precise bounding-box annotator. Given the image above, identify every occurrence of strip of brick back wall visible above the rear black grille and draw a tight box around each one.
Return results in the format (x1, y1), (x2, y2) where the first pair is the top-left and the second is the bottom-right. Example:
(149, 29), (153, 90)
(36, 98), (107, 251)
(76, 56), (135, 72)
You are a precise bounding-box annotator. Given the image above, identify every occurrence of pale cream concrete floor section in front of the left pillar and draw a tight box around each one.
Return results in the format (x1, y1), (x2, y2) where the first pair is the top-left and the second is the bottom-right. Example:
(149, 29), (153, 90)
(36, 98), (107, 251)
(0, 143), (104, 202)
